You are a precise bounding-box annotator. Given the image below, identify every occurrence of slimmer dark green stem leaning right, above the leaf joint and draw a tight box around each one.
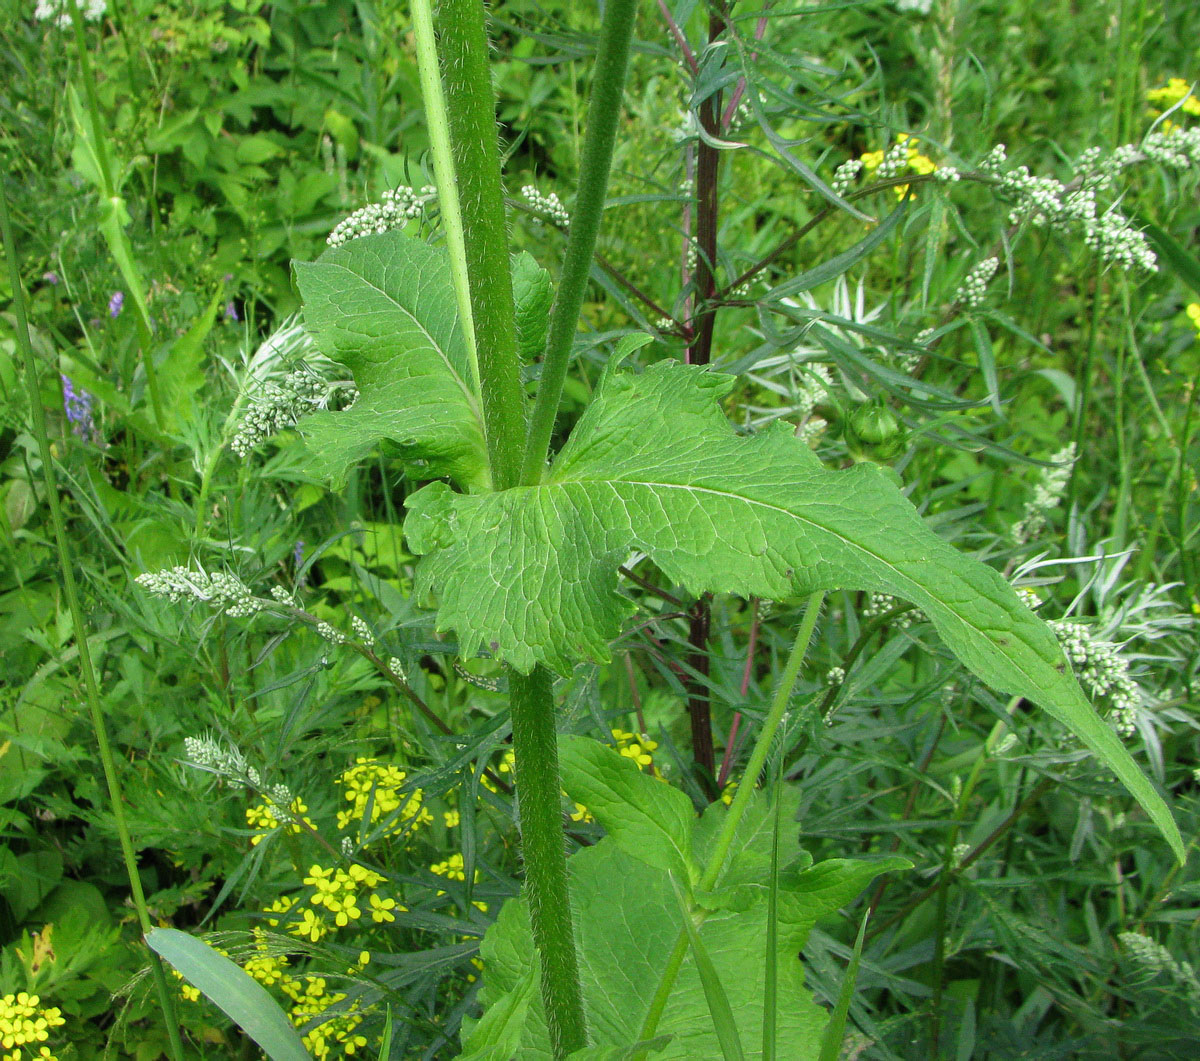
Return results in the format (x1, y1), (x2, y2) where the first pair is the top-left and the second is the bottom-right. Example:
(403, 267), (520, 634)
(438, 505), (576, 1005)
(521, 0), (637, 485)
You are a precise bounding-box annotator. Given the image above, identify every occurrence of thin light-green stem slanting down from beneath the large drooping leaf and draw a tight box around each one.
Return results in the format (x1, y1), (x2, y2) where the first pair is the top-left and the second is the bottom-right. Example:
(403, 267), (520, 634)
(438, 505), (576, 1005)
(637, 592), (824, 1039)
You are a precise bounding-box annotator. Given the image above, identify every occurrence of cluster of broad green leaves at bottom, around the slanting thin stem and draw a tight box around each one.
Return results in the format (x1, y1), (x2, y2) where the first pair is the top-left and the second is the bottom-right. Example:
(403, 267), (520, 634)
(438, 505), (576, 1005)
(463, 739), (907, 1059)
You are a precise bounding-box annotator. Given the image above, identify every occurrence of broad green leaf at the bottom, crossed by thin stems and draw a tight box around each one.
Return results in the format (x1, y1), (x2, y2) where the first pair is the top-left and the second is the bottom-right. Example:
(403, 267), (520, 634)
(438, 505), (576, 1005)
(468, 839), (907, 1061)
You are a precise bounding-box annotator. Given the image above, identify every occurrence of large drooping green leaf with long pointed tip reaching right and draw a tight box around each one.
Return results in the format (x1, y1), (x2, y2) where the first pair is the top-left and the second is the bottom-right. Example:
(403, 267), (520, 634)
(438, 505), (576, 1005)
(406, 361), (1183, 857)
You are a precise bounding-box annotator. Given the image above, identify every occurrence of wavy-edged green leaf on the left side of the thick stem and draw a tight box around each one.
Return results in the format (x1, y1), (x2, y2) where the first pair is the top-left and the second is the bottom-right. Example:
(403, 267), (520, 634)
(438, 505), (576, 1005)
(295, 230), (487, 486)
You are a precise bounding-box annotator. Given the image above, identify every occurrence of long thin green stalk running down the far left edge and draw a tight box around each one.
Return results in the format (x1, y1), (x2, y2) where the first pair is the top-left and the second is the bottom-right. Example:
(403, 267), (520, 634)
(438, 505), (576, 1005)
(0, 186), (184, 1061)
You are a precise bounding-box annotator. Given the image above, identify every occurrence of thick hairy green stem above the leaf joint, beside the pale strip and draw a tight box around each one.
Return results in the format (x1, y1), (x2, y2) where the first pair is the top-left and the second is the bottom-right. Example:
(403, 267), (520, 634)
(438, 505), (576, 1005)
(431, 0), (526, 490)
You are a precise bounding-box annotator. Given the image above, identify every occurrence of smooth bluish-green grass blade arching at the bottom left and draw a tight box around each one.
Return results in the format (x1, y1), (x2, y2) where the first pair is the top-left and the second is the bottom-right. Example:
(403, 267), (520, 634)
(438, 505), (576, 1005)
(146, 929), (312, 1061)
